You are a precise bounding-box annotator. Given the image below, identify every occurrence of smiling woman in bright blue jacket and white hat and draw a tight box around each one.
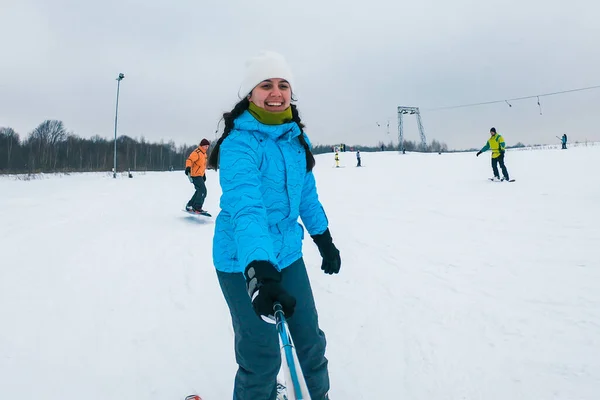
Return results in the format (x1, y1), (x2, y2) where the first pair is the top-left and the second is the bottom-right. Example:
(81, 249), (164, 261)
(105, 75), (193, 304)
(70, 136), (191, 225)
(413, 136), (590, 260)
(209, 52), (341, 400)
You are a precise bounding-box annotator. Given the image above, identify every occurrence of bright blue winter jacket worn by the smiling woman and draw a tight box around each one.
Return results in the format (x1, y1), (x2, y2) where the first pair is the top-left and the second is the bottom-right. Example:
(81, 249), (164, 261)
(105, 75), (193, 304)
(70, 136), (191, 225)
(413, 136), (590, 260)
(213, 111), (328, 272)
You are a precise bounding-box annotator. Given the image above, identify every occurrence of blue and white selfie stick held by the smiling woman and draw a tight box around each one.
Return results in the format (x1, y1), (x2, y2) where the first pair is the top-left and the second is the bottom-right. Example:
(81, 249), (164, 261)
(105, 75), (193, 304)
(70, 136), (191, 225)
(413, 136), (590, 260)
(273, 302), (310, 400)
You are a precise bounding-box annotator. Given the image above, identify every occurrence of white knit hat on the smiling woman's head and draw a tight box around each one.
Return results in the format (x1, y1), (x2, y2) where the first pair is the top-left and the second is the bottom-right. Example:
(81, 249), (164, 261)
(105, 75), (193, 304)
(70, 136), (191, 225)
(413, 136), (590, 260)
(238, 50), (294, 99)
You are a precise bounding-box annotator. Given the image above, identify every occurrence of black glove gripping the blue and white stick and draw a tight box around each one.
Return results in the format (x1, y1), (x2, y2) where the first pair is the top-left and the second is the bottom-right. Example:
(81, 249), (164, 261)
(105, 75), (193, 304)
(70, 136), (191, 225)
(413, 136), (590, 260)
(244, 261), (296, 320)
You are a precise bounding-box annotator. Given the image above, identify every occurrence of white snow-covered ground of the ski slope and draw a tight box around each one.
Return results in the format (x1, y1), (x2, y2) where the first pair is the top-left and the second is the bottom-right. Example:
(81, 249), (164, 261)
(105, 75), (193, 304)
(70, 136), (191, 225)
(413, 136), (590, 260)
(0, 146), (600, 400)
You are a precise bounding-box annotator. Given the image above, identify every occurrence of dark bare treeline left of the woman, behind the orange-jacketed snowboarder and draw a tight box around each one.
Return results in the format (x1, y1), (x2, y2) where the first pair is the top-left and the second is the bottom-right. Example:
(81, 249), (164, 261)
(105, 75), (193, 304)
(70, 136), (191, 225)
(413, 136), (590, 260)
(0, 120), (196, 173)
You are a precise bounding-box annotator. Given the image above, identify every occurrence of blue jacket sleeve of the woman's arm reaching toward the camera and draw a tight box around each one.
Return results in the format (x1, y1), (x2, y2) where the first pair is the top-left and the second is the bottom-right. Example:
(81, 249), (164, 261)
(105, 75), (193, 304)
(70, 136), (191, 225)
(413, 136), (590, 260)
(219, 132), (277, 268)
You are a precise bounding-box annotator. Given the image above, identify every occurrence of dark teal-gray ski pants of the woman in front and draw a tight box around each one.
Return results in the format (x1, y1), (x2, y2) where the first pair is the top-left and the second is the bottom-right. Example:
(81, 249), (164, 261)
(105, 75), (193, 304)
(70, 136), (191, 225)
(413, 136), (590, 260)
(217, 258), (329, 400)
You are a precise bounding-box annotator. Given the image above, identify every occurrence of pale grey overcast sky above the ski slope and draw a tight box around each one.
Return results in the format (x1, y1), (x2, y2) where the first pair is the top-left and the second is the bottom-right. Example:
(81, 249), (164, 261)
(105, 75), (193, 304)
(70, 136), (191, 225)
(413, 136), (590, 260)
(0, 0), (600, 148)
